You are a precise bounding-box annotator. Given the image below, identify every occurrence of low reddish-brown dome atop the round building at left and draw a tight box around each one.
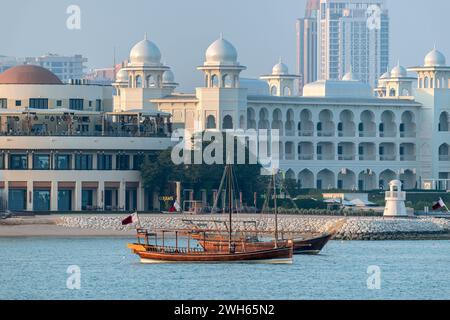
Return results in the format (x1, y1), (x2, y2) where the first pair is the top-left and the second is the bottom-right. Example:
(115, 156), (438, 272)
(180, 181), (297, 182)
(0, 65), (63, 85)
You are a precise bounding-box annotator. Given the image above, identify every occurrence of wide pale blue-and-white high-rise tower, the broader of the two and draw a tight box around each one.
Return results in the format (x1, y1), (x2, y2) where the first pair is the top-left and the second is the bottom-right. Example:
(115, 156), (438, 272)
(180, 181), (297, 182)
(317, 0), (389, 87)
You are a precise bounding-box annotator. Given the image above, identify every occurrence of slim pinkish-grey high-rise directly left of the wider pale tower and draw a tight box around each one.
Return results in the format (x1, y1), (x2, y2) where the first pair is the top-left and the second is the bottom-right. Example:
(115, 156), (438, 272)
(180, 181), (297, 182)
(296, 0), (320, 95)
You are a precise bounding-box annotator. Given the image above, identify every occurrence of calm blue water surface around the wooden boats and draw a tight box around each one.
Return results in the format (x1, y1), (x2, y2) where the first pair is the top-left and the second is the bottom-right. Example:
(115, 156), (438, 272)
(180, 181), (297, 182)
(0, 238), (450, 300)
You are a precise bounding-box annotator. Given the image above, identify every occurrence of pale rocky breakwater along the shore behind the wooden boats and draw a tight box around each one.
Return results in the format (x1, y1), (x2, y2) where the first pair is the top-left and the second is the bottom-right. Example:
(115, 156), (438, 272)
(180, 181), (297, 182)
(57, 215), (450, 240)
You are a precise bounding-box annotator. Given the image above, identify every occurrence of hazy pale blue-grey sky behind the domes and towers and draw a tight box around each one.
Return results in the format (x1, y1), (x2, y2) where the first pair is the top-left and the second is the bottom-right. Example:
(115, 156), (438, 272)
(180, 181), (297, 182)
(0, 0), (450, 91)
